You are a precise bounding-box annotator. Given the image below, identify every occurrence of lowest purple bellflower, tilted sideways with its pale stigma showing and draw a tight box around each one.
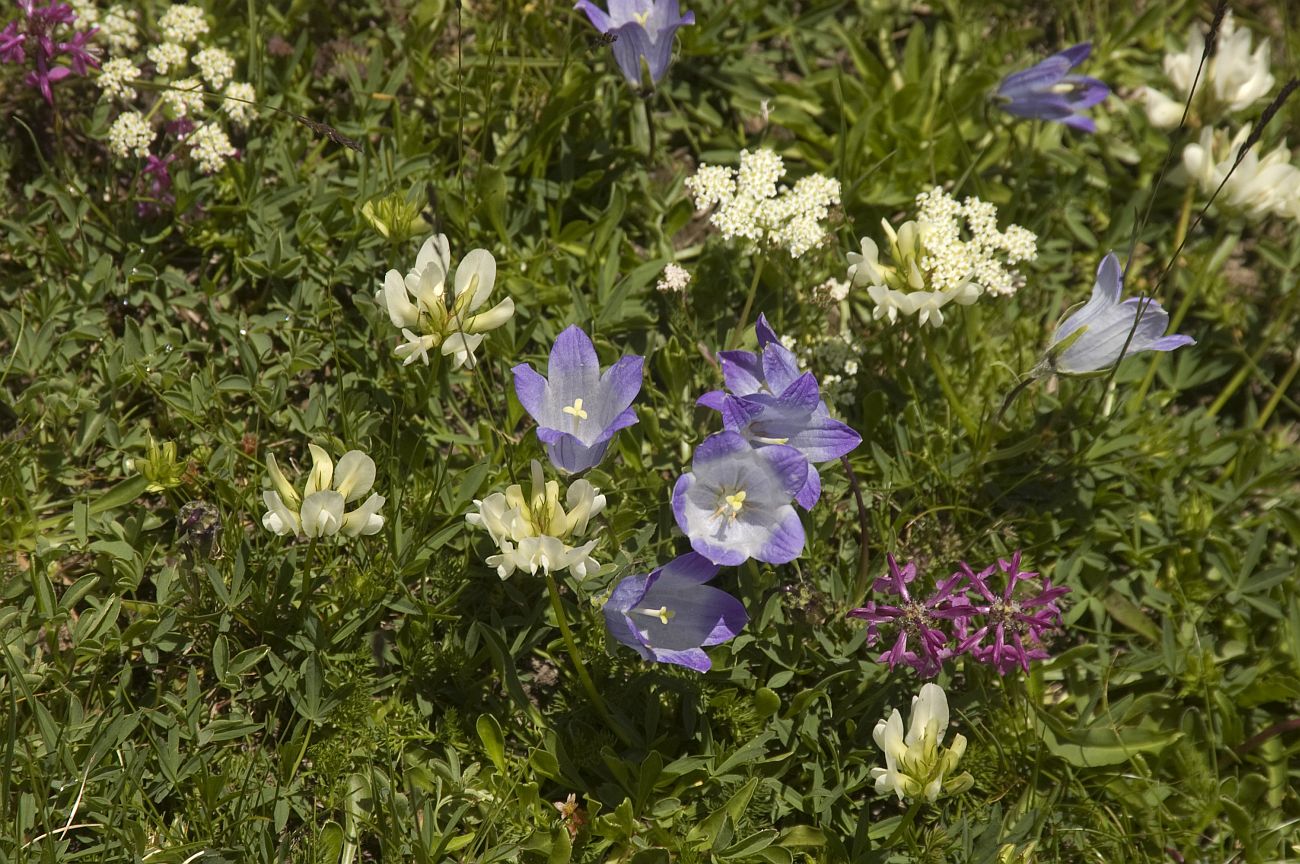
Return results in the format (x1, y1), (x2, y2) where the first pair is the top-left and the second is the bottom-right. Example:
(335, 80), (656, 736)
(605, 552), (749, 672)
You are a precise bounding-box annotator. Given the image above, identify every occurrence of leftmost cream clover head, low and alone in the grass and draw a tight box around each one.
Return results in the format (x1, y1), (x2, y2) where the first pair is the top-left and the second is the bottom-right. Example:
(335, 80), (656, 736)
(261, 444), (385, 538)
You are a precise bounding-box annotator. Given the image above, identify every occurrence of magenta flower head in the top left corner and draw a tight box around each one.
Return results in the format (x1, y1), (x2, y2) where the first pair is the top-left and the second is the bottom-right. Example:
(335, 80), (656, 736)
(0, 0), (99, 105)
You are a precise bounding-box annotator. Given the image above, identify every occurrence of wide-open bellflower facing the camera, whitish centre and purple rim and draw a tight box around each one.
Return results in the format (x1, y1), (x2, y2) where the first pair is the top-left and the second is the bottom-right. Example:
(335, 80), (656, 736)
(672, 431), (809, 565)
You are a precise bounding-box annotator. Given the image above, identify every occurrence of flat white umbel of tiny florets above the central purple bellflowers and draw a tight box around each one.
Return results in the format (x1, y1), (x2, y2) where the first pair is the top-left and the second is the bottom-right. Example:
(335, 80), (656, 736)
(686, 149), (840, 259)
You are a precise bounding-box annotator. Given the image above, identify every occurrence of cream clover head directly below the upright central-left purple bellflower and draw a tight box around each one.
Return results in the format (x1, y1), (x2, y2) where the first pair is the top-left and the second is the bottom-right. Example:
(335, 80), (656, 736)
(465, 459), (605, 579)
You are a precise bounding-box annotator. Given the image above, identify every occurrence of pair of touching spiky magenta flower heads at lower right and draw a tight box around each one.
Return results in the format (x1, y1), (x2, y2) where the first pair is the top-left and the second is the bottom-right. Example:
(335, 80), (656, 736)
(849, 552), (1070, 678)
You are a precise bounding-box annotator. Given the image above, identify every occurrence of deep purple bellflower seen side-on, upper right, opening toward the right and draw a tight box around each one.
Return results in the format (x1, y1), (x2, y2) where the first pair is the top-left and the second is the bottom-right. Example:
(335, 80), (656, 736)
(993, 42), (1110, 133)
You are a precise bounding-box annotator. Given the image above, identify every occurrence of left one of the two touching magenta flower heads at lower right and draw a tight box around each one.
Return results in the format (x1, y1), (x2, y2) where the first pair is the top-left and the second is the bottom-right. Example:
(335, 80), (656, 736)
(849, 555), (974, 678)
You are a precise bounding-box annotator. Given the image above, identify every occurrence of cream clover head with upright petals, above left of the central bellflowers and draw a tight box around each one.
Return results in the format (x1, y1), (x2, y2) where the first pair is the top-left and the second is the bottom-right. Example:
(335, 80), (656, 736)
(374, 234), (515, 369)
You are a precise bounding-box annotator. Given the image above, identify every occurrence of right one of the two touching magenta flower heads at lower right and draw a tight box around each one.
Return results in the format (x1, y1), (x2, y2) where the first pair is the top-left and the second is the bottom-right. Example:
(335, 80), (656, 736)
(957, 552), (1070, 676)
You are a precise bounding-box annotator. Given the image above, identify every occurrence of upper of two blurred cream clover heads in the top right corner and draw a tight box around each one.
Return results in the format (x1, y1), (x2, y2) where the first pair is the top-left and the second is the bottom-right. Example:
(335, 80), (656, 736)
(1143, 12), (1274, 129)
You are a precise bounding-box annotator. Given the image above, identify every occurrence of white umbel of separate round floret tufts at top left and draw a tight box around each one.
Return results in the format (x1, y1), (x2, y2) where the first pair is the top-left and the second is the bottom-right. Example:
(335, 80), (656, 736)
(93, 0), (256, 174)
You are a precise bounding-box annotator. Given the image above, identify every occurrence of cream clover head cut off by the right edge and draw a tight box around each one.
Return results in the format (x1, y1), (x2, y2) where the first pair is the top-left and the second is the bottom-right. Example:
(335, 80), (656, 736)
(1183, 127), (1300, 221)
